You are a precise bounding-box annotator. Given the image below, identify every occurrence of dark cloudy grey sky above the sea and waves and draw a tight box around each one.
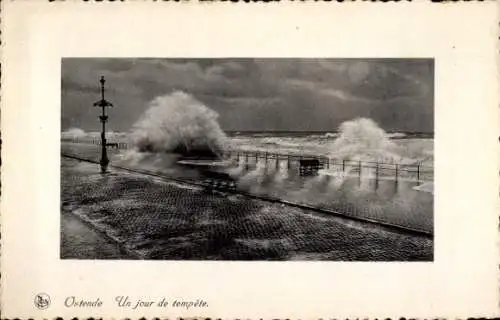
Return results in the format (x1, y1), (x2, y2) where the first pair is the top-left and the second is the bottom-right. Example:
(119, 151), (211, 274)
(61, 58), (434, 132)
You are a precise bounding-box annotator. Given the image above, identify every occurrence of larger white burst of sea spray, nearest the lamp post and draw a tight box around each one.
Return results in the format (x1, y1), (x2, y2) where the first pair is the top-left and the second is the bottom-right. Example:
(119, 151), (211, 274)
(109, 91), (228, 178)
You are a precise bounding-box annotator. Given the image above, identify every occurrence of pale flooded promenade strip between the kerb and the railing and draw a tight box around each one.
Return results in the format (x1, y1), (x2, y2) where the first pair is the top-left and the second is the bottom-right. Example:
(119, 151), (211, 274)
(62, 143), (434, 234)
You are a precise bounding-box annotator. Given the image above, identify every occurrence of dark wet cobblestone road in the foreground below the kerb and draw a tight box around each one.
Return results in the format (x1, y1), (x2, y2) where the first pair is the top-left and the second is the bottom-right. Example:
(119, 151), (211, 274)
(61, 158), (433, 261)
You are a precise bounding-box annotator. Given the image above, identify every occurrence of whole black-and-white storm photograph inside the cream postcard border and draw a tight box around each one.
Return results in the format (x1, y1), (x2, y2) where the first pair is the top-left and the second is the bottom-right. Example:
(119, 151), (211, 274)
(60, 57), (435, 262)
